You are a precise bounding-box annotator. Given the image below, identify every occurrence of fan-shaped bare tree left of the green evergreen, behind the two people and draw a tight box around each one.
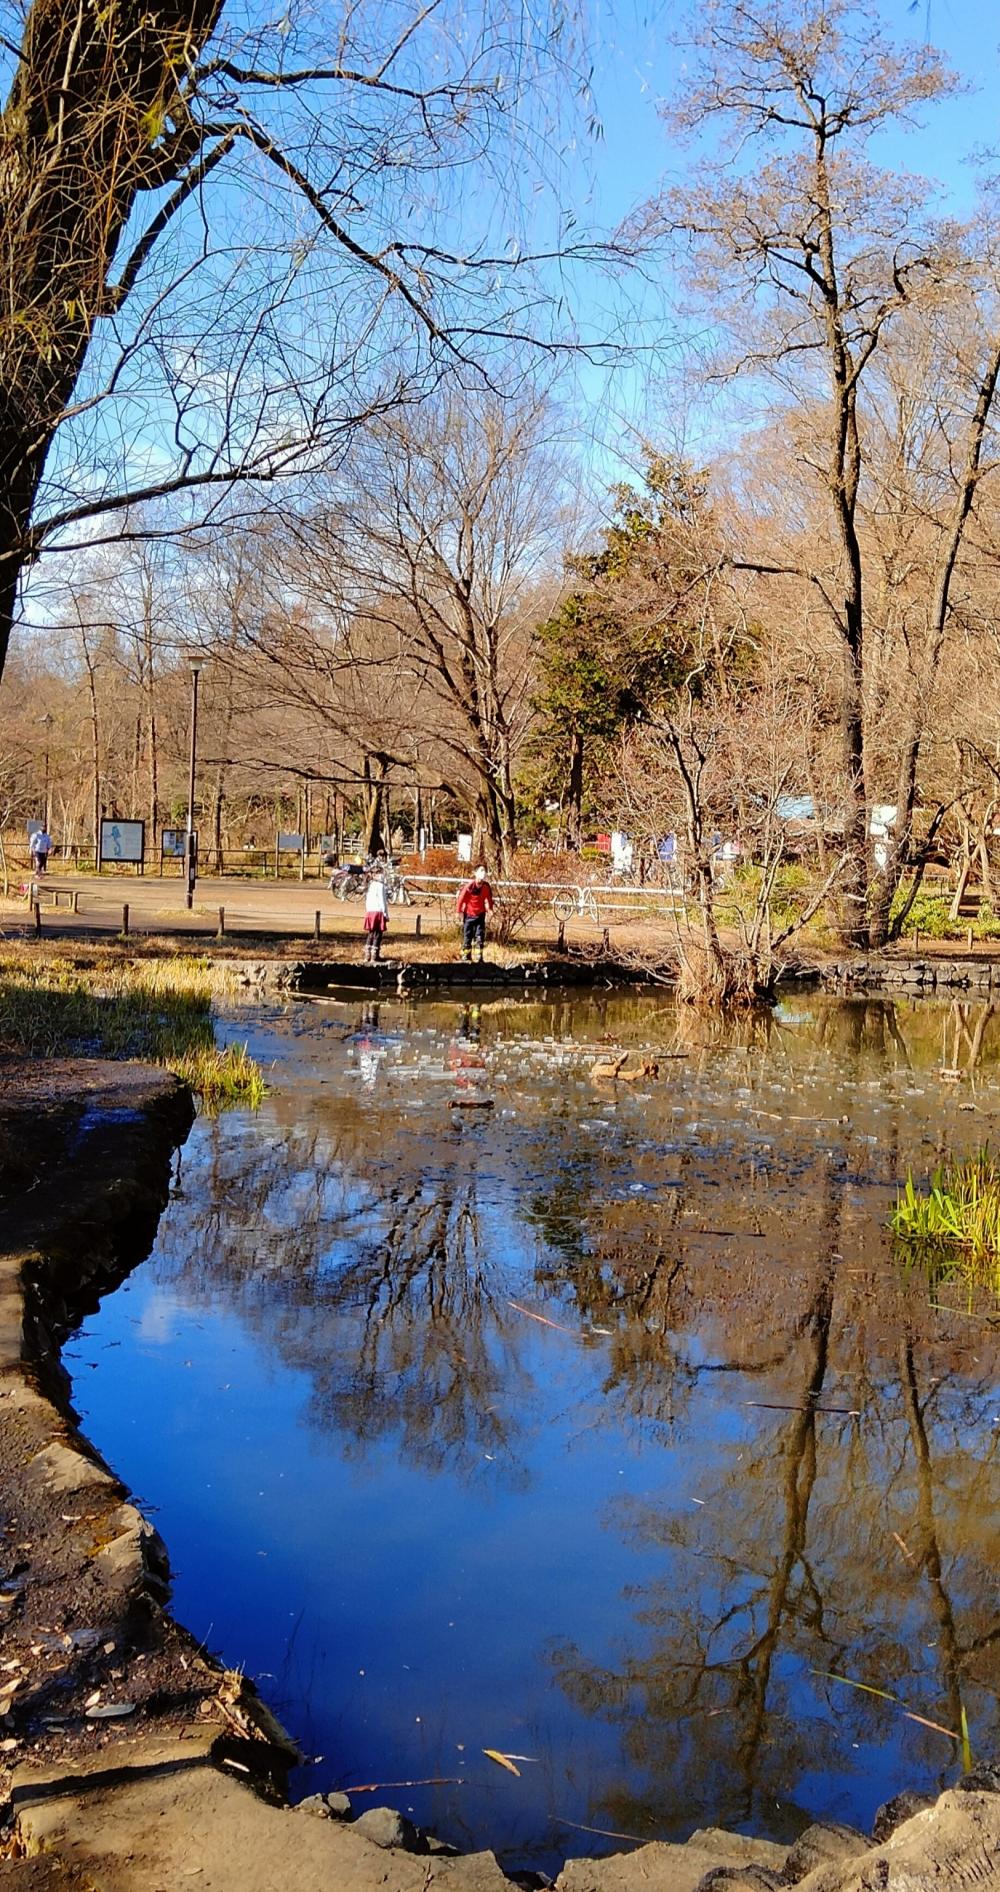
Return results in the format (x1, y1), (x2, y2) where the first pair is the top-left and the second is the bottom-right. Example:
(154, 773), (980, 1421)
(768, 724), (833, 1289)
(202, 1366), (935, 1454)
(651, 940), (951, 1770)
(285, 390), (563, 865)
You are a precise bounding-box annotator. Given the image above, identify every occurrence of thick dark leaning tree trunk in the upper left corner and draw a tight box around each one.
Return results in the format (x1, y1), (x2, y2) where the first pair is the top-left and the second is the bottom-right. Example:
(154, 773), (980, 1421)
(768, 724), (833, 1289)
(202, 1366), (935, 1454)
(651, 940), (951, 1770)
(0, 0), (219, 675)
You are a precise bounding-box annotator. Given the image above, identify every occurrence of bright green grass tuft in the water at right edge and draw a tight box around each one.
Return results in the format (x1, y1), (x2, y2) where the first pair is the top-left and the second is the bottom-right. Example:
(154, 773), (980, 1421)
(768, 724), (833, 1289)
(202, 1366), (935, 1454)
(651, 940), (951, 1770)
(890, 1148), (1000, 1288)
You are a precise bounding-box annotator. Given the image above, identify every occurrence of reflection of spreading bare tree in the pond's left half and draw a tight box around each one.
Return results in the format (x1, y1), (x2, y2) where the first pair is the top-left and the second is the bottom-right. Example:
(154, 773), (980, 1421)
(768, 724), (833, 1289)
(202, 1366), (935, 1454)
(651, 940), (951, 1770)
(162, 1111), (533, 1468)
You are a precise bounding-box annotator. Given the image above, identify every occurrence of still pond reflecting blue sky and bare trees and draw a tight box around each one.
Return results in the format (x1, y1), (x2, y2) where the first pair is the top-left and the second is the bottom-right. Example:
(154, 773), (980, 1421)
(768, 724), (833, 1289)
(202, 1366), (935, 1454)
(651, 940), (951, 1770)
(66, 995), (1000, 1869)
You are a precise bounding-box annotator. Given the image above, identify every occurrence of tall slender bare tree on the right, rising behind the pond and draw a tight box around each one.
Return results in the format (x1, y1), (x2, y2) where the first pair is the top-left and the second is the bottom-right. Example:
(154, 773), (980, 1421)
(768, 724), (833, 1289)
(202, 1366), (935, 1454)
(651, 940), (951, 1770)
(638, 0), (1000, 944)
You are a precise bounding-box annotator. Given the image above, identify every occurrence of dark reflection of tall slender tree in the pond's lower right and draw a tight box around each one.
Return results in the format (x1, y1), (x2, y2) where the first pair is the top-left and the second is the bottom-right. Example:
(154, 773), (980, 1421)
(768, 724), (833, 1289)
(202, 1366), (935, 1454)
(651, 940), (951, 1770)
(540, 1169), (1000, 1830)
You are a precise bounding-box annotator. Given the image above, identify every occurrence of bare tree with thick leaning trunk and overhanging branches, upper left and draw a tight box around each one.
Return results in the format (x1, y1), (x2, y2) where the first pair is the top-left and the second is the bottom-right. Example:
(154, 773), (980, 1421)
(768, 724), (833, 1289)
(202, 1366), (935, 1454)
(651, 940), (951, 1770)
(0, 0), (601, 688)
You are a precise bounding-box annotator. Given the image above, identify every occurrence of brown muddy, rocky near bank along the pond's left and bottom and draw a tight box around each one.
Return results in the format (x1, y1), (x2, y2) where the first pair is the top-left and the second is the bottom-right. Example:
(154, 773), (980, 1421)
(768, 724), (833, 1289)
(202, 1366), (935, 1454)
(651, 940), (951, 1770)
(0, 1060), (1000, 1892)
